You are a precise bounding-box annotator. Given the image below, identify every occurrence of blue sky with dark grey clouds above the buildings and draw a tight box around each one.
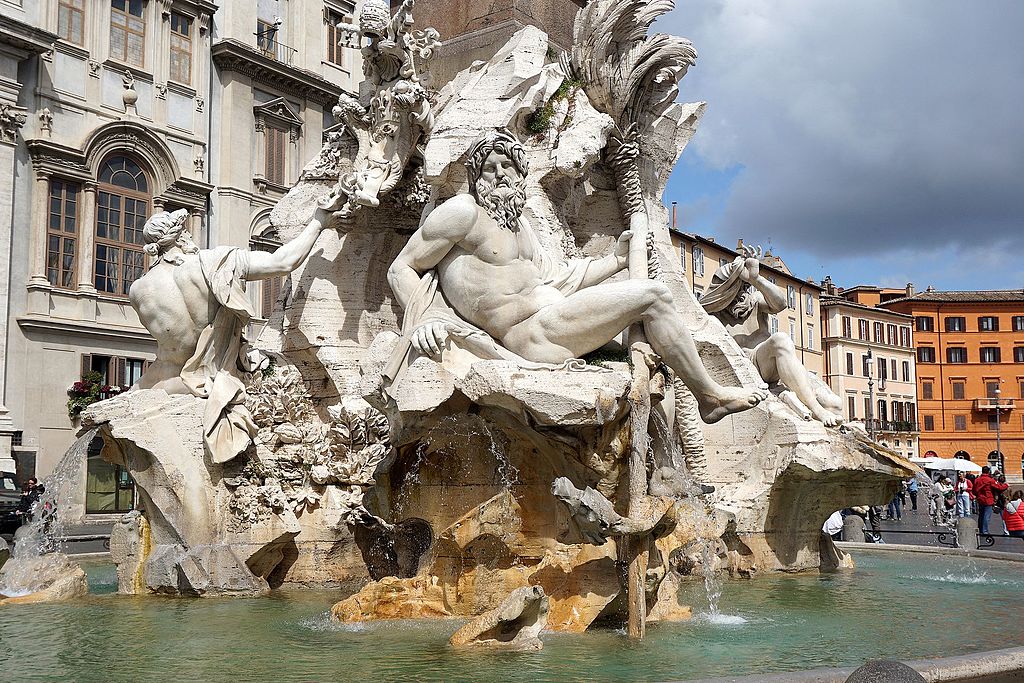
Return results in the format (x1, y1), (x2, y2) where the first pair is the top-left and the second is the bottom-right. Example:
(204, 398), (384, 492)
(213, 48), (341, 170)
(654, 0), (1024, 290)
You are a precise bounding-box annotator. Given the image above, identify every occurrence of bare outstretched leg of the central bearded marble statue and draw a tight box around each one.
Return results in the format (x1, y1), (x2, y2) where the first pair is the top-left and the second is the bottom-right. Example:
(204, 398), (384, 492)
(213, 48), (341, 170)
(502, 280), (768, 422)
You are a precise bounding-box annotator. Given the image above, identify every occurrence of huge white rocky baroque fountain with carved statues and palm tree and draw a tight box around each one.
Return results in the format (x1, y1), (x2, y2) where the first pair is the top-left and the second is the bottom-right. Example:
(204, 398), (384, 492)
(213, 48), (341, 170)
(0, 0), (912, 648)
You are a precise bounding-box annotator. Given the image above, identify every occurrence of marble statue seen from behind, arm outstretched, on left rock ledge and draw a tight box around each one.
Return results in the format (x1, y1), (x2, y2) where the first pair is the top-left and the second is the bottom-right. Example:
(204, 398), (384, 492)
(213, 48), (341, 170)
(128, 209), (327, 463)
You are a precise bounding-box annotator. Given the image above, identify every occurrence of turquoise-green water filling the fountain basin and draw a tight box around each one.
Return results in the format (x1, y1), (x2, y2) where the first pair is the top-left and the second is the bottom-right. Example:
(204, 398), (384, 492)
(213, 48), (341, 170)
(0, 552), (1024, 683)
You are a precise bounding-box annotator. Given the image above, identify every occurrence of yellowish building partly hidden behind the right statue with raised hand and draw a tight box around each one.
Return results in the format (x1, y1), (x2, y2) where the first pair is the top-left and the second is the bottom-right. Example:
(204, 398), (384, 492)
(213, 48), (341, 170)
(670, 228), (824, 377)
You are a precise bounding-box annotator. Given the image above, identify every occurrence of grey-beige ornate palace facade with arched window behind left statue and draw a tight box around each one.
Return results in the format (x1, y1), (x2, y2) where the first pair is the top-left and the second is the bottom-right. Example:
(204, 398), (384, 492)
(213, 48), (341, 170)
(0, 0), (361, 515)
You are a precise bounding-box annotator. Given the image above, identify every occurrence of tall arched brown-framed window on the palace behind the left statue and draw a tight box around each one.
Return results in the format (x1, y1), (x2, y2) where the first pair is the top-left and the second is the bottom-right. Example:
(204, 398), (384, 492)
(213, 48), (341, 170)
(95, 157), (151, 296)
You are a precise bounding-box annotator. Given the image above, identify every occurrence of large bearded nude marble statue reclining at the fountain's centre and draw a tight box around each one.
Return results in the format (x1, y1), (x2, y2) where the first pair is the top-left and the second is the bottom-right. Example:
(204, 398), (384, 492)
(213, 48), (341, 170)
(388, 130), (767, 423)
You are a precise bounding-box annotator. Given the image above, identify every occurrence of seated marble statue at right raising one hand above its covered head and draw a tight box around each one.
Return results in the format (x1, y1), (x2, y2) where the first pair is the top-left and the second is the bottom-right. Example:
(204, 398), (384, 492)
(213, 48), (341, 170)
(700, 247), (843, 427)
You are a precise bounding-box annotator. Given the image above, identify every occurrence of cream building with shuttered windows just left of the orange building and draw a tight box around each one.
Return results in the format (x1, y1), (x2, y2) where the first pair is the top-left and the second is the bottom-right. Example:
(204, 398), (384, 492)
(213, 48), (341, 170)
(821, 278), (919, 458)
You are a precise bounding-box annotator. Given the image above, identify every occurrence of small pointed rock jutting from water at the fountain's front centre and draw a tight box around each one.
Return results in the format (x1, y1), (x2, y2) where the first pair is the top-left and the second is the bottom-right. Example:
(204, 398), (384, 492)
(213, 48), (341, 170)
(449, 586), (548, 650)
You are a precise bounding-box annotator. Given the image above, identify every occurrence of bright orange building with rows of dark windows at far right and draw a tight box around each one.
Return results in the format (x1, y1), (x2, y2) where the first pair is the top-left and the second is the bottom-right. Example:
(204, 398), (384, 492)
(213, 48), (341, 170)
(882, 290), (1024, 482)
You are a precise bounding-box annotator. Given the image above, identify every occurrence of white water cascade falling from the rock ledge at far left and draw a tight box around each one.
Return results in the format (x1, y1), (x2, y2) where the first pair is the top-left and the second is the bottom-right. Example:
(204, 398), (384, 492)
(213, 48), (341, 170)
(0, 429), (96, 597)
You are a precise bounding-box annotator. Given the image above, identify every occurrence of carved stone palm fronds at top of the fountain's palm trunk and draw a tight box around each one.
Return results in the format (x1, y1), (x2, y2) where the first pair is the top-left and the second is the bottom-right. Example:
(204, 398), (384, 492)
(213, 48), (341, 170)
(562, 0), (697, 131)
